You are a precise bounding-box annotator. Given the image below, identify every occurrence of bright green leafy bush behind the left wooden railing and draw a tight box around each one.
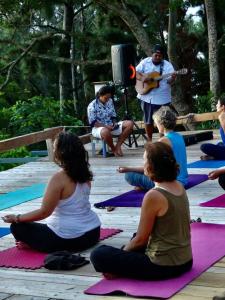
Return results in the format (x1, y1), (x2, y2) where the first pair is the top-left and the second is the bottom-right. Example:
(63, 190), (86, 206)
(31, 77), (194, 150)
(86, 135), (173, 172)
(4, 96), (82, 136)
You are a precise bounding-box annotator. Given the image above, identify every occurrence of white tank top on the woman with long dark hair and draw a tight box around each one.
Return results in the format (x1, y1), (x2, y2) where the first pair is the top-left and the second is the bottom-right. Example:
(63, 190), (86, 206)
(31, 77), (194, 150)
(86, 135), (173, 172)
(47, 183), (101, 239)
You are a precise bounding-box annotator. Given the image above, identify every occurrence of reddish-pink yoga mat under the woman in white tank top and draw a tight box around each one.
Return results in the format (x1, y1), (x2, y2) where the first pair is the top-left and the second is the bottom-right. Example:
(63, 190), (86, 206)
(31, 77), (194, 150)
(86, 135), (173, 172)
(0, 228), (122, 270)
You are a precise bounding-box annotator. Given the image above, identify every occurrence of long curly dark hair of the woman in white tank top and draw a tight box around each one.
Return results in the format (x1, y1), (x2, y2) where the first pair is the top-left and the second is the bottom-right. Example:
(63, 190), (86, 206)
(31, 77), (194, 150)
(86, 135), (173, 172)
(54, 132), (93, 183)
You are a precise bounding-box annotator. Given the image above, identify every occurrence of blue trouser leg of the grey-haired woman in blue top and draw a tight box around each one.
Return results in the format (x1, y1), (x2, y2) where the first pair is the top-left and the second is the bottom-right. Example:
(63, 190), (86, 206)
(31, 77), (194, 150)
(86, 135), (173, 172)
(125, 172), (155, 190)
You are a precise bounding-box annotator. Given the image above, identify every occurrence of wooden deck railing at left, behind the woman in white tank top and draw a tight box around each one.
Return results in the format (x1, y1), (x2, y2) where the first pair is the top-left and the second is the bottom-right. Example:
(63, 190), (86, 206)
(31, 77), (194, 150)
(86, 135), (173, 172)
(0, 126), (91, 161)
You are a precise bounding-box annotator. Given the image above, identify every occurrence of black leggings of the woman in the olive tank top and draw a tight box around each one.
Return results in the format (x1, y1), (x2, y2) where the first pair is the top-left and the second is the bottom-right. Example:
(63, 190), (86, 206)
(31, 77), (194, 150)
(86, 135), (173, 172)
(90, 245), (193, 280)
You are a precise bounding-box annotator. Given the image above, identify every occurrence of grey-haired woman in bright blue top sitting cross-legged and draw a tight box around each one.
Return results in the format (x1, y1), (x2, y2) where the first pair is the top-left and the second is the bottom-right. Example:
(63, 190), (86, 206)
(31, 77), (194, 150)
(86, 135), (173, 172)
(118, 106), (188, 190)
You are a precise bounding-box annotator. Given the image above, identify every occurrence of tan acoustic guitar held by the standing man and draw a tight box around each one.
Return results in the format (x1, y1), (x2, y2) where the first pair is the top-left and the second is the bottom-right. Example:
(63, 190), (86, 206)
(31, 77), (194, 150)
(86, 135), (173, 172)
(135, 69), (188, 95)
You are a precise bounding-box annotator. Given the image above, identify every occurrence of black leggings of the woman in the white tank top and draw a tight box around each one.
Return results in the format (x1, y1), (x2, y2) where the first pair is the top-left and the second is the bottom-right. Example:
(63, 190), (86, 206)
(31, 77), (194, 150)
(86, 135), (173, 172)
(10, 222), (100, 253)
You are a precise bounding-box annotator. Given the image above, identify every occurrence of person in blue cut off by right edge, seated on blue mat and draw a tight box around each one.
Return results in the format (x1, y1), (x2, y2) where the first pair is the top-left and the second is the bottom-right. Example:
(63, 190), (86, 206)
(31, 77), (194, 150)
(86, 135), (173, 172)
(200, 95), (225, 160)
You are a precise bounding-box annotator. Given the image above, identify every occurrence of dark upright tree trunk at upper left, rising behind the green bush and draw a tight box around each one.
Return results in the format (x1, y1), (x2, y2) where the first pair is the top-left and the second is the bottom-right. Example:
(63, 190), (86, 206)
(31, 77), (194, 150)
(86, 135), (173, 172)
(59, 3), (74, 115)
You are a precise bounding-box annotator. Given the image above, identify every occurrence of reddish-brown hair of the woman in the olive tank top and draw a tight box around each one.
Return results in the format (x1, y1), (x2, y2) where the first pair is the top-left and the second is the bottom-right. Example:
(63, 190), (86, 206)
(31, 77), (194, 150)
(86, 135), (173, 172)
(145, 142), (179, 182)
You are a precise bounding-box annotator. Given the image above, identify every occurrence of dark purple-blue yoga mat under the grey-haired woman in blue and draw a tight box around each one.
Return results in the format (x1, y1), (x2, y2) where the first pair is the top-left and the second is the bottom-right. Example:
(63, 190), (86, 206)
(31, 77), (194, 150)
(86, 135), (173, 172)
(94, 174), (208, 208)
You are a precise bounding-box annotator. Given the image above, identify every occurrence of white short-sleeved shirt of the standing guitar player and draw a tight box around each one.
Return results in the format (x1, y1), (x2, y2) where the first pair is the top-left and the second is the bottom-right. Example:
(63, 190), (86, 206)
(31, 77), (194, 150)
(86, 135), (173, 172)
(136, 57), (174, 105)
